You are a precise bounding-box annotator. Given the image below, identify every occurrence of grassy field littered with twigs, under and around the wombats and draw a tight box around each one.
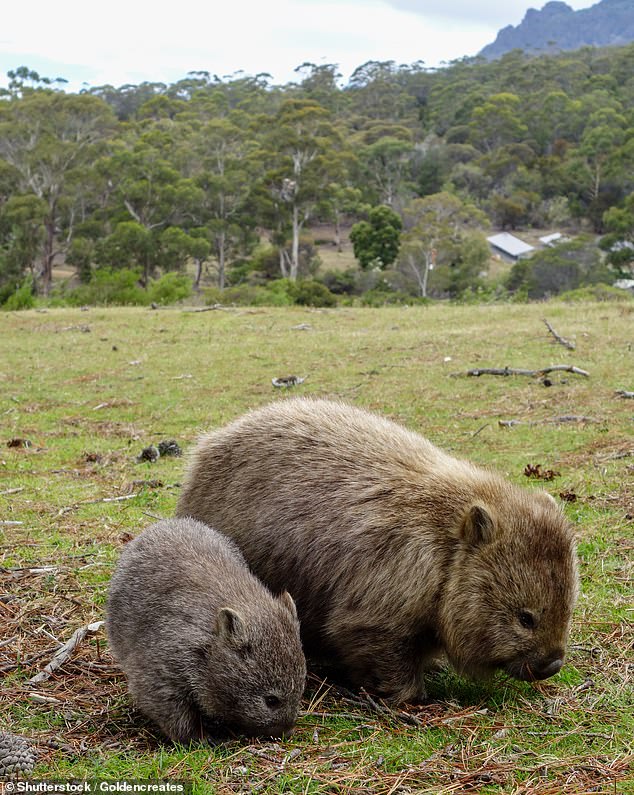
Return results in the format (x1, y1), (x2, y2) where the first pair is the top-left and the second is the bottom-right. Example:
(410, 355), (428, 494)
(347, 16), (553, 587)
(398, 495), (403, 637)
(0, 303), (634, 795)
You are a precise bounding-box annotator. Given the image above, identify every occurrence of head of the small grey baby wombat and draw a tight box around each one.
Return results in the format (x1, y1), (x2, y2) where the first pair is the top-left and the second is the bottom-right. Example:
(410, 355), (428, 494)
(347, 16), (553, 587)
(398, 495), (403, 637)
(200, 593), (306, 737)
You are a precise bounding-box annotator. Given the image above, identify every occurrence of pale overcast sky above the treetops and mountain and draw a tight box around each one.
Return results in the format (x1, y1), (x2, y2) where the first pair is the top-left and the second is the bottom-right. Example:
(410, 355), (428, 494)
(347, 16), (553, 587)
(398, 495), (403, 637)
(0, 0), (597, 90)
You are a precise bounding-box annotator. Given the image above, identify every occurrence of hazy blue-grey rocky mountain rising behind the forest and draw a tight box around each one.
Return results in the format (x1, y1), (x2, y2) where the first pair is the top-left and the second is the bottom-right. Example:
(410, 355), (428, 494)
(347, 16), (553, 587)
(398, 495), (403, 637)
(480, 0), (634, 60)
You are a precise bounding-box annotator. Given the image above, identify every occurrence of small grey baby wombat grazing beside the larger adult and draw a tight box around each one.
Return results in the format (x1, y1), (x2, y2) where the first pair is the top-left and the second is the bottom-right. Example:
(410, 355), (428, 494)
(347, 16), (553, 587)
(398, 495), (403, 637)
(106, 519), (306, 743)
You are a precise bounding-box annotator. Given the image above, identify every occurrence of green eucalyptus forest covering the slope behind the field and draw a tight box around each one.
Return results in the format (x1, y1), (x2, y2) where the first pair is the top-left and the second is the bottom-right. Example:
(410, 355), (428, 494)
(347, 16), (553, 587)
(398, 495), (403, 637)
(0, 45), (634, 308)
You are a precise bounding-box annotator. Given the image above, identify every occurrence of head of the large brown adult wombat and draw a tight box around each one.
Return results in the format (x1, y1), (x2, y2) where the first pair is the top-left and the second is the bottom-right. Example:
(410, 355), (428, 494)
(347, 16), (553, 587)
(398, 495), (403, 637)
(441, 489), (578, 680)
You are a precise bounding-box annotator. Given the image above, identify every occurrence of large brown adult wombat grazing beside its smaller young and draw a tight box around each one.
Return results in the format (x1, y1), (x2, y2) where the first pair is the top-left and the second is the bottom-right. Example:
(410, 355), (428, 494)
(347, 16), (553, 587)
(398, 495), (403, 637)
(177, 399), (577, 701)
